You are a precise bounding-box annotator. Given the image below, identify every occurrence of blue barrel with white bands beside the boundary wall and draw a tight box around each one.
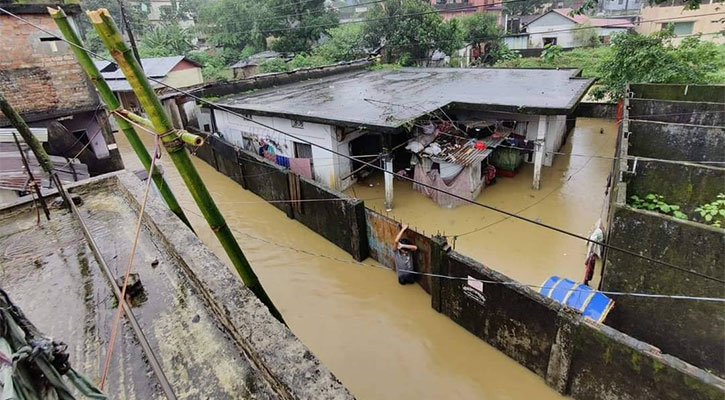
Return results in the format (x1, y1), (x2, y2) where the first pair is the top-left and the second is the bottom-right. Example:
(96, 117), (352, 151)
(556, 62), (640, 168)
(539, 276), (614, 323)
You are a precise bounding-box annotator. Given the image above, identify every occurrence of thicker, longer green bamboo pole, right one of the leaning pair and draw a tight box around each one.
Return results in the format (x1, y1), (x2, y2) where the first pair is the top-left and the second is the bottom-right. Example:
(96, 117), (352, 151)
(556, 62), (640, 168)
(86, 8), (284, 322)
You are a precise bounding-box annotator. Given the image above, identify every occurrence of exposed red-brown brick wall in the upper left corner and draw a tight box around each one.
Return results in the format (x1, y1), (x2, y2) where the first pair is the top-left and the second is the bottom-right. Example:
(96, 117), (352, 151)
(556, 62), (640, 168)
(0, 14), (98, 120)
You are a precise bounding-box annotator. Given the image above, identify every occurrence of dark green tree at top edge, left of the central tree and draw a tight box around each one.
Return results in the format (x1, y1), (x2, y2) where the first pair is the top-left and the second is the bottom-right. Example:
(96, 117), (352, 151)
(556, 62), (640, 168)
(264, 0), (339, 53)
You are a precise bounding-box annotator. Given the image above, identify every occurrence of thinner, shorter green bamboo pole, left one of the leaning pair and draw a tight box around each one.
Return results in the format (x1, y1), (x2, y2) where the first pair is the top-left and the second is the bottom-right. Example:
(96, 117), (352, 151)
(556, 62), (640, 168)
(48, 7), (193, 230)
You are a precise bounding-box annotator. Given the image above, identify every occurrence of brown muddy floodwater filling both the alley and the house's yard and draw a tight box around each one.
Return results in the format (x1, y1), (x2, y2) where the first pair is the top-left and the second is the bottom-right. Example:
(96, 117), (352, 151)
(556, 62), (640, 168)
(111, 120), (615, 400)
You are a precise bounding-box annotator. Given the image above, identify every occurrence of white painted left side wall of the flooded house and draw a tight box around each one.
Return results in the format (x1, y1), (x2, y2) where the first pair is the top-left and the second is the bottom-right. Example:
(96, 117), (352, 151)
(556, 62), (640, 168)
(212, 110), (362, 190)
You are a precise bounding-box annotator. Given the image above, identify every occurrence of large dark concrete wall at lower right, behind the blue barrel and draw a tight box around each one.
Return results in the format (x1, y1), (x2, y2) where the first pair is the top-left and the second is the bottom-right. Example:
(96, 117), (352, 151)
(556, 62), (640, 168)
(602, 206), (725, 376)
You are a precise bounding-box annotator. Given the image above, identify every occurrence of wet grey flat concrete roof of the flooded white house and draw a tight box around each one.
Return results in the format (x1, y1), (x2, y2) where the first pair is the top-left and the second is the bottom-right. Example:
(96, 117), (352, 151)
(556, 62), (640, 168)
(217, 68), (594, 130)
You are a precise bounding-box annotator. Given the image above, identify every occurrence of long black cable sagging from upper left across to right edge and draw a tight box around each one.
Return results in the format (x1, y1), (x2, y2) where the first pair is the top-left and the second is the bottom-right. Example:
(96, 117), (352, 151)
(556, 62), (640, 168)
(0, 7), (725, 283)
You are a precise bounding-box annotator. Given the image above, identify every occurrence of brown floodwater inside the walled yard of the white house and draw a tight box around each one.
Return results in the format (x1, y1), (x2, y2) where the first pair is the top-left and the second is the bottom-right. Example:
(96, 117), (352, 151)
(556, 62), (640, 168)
(346, 118), (617, 285)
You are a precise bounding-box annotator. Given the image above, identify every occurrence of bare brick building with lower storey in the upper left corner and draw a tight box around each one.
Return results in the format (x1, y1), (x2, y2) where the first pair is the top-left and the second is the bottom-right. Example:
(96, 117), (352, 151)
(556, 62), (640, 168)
(0, 0), (123, 185)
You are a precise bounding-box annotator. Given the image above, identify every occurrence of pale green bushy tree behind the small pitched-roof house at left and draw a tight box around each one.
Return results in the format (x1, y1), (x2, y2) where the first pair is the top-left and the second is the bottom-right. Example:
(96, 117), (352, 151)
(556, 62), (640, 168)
(139, 23), (194, 57)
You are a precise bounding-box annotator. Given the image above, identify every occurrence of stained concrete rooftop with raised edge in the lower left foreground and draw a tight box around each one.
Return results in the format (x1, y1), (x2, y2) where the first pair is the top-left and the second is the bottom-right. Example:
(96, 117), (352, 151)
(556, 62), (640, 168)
(0, 171), (353, 400)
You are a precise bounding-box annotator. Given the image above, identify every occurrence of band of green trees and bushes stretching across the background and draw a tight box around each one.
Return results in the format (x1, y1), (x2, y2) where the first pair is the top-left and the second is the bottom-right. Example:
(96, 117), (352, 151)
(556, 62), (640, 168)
(81, 0), (725, 94)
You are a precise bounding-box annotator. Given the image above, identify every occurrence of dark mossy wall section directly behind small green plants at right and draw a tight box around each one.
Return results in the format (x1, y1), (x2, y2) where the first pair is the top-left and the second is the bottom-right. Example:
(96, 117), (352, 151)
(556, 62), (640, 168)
(626, 160), (725, 217)
